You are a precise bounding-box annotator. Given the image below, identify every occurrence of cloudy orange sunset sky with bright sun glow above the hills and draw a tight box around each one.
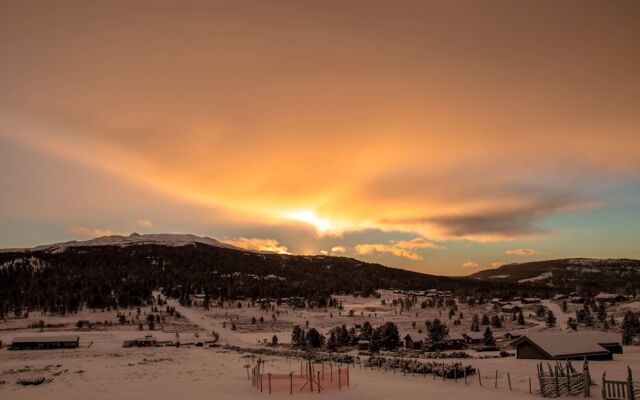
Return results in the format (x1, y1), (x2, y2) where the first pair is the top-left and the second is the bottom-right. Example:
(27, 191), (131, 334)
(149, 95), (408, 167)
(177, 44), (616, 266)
(0, 0), (640, 275)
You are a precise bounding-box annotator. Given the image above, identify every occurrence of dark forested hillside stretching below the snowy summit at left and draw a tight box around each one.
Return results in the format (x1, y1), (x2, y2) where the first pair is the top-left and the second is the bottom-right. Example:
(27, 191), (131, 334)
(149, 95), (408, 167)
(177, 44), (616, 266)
(0, 244), (553, 318)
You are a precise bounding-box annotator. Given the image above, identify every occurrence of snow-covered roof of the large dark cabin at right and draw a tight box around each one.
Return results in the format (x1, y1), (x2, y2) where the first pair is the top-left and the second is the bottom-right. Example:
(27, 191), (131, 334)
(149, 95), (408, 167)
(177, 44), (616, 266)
(513, 332), (620, 358)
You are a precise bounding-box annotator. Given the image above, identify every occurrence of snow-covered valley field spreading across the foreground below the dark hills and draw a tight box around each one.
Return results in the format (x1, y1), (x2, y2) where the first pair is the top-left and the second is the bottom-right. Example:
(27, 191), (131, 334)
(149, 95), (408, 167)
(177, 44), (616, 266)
(0, 292), (640, 400)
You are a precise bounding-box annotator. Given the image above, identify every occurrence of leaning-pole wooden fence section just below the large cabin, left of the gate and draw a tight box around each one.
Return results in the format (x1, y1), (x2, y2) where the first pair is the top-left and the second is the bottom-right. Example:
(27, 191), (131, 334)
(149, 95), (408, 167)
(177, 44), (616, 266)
(538, 361), (591, 397)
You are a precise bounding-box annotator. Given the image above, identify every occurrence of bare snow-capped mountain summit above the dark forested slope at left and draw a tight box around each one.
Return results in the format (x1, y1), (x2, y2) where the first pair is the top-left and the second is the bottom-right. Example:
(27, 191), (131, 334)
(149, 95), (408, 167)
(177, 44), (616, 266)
(2, 233), (245, 253)
